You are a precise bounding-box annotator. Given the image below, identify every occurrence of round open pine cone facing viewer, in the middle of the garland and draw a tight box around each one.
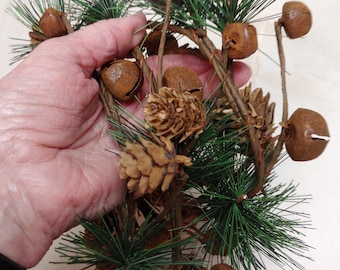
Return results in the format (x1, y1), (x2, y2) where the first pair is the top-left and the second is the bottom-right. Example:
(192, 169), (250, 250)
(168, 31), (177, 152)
(144, 87), (206, 142)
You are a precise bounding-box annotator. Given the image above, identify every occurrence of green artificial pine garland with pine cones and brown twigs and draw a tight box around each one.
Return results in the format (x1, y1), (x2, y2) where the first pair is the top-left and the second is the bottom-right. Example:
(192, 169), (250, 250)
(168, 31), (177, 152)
(5, 0), (330, 270)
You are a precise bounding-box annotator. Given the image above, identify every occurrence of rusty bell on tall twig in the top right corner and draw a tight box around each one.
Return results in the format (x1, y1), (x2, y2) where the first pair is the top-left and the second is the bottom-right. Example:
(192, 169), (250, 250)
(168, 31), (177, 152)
(280, 1), (312, 39)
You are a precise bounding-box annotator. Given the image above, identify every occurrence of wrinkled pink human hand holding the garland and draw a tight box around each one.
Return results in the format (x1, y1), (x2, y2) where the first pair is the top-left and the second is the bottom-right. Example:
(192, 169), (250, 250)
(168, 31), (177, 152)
(0, 14), (249, 267)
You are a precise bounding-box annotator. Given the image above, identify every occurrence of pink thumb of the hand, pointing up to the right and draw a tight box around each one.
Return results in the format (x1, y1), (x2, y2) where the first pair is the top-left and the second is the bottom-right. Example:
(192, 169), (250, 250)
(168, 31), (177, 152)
(23, 13), (146, 77)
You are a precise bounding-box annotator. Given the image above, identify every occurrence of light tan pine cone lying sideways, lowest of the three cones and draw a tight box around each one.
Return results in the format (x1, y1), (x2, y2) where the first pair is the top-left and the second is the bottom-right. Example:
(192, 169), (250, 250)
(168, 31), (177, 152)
(118, 137), (192, 194)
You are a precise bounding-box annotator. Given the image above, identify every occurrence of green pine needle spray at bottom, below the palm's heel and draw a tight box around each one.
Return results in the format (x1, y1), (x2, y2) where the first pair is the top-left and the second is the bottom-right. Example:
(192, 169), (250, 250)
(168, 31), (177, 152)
(55, 205), (203, 270)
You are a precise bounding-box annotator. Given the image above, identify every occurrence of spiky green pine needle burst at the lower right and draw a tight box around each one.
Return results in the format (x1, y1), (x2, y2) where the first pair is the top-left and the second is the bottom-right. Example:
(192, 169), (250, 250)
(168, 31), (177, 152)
(193, 176), (310, 270)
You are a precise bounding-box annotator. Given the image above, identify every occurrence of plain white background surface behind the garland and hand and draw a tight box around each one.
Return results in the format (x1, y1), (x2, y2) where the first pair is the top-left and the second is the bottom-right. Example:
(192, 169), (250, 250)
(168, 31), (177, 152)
(0, 0), (340, 270)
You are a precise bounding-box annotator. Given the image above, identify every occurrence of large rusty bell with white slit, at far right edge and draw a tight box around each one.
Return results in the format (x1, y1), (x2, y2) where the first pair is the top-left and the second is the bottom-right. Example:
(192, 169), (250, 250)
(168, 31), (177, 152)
(285, 108), (329, 161)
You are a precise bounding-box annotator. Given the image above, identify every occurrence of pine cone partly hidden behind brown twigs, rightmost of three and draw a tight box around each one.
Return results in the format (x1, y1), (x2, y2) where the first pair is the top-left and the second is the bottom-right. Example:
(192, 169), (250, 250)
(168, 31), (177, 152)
(217, 85), (276, 148)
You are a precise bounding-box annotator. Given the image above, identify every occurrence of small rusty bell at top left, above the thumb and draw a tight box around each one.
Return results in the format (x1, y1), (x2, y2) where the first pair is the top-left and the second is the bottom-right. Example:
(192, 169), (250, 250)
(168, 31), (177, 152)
(39, 7), (67, 37)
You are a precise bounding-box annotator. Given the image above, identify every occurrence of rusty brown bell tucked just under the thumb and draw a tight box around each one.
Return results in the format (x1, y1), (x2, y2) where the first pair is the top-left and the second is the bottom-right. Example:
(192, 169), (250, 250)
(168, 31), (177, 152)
(101, 59), (144, 102)
